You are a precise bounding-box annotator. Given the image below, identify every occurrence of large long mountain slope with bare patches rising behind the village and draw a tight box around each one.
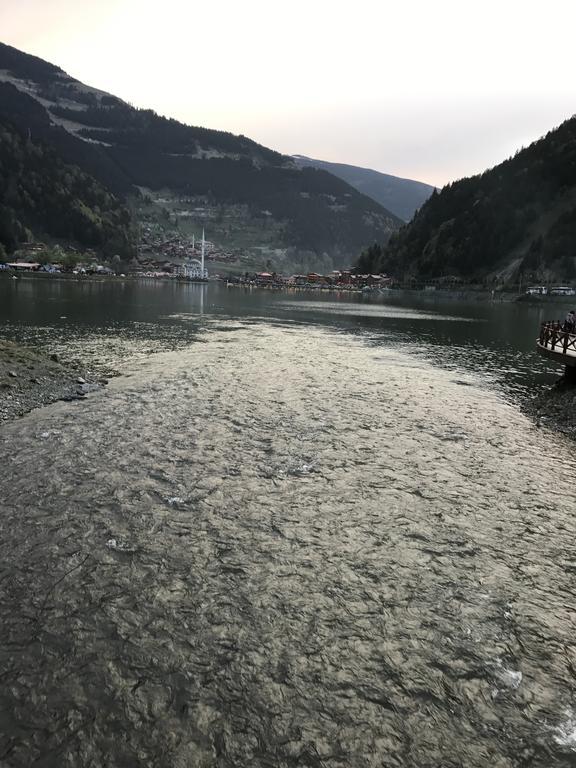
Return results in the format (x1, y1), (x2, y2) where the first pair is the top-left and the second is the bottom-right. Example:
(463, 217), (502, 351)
(0, 44), (401, 266)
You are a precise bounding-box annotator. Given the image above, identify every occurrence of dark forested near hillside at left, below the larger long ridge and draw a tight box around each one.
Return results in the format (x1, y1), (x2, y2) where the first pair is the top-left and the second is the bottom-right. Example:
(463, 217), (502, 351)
(0, 118), (132, 257)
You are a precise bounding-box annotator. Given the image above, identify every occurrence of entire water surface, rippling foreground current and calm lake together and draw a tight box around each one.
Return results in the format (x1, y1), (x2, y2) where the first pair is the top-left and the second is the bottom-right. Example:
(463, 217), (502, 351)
(0, 279), (576, 768)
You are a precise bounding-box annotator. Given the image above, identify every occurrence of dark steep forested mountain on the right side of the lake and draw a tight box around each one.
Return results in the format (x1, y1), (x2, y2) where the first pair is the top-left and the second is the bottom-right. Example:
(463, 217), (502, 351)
(364, 117), (576, 283)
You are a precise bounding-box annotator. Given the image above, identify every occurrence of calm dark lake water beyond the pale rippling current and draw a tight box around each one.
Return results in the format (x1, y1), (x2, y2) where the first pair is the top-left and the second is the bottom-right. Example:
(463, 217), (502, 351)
(0, 279), (570, 399)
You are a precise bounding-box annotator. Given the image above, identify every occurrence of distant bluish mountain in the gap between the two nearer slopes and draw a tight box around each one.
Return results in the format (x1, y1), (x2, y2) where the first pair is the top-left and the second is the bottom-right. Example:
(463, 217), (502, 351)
(294, 155), (434, 221)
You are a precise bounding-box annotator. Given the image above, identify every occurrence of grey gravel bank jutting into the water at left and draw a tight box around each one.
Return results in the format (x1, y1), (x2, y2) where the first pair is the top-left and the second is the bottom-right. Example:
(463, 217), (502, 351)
(0, 340), (108, 423)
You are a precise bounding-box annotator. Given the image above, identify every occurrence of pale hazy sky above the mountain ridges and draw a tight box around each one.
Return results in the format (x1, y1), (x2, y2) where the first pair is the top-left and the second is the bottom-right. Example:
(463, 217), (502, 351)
(0, 0), (576, 186)
